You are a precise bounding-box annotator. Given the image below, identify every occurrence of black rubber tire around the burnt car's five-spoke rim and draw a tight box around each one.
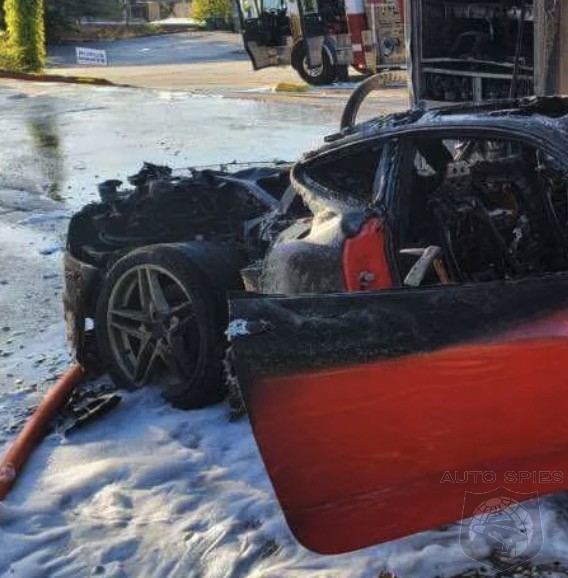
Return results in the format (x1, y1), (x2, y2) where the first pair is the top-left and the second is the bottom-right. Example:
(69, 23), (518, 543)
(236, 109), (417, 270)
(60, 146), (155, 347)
(95, 245), (226, 409)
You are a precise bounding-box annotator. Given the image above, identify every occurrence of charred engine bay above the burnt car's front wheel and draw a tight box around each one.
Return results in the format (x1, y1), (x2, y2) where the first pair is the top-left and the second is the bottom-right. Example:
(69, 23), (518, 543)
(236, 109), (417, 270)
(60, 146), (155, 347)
(70, 162), (303, 265)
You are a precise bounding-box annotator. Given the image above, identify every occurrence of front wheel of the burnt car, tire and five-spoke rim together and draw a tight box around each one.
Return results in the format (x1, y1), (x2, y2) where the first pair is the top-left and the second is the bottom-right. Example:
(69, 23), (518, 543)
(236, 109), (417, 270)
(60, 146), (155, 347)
(95, 245), (225, 409)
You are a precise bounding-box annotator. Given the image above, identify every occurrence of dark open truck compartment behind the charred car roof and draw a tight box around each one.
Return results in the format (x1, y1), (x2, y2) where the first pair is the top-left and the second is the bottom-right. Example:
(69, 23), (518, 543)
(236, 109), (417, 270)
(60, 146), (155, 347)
(416, 0), (535, 102)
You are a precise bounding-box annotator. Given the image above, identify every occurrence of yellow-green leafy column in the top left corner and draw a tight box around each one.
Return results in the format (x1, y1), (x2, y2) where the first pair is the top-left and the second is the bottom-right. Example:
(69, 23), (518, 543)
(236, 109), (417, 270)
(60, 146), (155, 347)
(4, 0), (45, 72)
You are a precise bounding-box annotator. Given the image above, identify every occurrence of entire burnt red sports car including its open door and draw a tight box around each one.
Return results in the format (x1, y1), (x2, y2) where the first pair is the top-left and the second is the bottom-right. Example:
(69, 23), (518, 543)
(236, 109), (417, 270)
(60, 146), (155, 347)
(65, 97), (568, 553)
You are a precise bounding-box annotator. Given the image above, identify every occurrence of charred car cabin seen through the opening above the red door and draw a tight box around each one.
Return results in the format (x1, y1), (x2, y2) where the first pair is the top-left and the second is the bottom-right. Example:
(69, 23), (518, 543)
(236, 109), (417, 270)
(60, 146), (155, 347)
(397, 133), (568, 284)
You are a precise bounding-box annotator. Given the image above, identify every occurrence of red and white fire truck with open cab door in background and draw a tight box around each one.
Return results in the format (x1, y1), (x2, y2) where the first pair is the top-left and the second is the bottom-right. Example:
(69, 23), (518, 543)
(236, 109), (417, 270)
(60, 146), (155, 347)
(236, 0), (406, 85)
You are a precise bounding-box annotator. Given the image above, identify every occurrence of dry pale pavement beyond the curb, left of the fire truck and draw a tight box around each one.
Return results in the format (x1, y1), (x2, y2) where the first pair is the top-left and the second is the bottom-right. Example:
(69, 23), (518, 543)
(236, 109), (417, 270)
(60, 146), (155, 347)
(45, 31), (408, 108)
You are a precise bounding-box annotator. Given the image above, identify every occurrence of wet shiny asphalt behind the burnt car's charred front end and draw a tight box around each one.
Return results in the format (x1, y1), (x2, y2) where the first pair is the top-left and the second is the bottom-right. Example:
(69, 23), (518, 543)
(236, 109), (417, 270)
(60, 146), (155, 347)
(0, 83), (339, 208)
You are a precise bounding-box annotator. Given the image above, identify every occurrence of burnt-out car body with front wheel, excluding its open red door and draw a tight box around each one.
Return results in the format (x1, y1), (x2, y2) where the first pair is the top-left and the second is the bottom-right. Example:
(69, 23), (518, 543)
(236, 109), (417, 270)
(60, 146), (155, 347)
(65, 98), (568, 407)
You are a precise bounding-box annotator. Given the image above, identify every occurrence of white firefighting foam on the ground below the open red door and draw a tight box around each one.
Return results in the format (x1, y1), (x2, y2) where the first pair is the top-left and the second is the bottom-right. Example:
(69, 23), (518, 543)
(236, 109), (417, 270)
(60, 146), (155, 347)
(0, 327), (567, 578)
